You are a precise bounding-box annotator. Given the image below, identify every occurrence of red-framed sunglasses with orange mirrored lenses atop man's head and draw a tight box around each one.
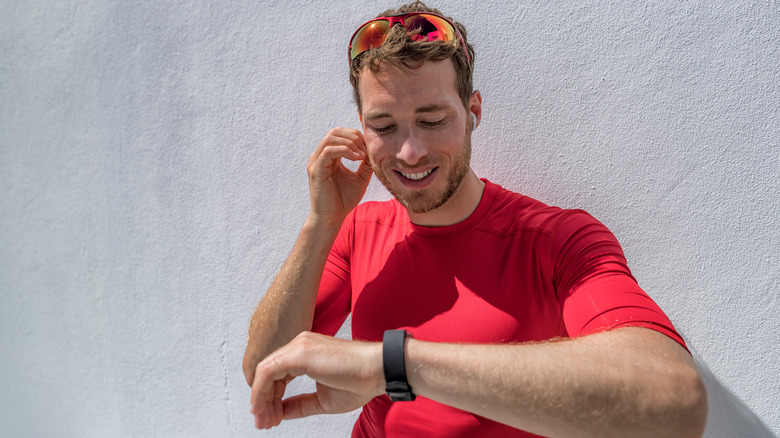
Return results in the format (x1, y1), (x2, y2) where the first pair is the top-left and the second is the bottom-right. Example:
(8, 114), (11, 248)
(349, 12), (471, 64)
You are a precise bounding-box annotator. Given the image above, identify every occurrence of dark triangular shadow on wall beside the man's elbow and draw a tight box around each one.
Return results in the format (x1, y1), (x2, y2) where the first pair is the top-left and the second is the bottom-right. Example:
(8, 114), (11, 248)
(696, 360), (778, 438)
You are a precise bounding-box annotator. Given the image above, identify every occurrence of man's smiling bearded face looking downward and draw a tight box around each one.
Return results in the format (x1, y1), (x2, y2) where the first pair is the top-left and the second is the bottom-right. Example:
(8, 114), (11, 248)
(358, 59), (471, 213)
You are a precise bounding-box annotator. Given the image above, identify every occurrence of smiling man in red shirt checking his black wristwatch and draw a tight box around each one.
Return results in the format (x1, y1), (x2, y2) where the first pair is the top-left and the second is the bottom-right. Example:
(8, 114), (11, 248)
(244, 2), (706, 437)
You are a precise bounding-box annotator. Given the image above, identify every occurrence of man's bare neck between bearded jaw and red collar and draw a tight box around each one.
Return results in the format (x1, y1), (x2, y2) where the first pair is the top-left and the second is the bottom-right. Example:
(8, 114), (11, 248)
(409, 169), (485, 227)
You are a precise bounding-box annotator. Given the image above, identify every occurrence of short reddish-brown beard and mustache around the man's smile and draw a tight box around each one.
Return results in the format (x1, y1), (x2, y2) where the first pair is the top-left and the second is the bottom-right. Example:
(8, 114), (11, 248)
(371, 130), (471, 213)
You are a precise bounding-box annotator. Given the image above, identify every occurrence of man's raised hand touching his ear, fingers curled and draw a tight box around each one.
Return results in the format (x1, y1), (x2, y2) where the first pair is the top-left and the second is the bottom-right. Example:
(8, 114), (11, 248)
(306, 128), (373, 225)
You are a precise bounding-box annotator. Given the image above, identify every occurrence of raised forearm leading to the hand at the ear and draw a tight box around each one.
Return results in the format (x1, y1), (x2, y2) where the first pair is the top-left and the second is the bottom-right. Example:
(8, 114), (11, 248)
(243, 218), (339, 385)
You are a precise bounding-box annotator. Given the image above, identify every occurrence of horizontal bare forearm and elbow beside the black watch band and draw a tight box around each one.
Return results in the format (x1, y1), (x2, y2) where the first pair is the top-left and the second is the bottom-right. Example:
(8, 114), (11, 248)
(407, 328), (706, 437)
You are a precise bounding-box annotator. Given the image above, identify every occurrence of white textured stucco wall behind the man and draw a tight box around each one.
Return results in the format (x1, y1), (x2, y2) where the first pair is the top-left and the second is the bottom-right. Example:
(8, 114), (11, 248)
(0, 0), (780, 438)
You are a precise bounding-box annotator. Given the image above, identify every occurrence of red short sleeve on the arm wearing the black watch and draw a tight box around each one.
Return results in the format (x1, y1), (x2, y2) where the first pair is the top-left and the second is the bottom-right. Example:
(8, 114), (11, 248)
(552, 210), (687, 349)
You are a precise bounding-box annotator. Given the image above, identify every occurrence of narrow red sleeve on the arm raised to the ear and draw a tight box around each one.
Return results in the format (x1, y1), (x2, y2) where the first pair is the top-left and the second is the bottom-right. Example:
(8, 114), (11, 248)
(312, 211), (354, 336)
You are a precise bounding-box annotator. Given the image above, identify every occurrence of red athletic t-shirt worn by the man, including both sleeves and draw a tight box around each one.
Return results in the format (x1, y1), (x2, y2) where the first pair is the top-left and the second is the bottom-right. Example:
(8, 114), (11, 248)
(313, 180), (685, 437)
